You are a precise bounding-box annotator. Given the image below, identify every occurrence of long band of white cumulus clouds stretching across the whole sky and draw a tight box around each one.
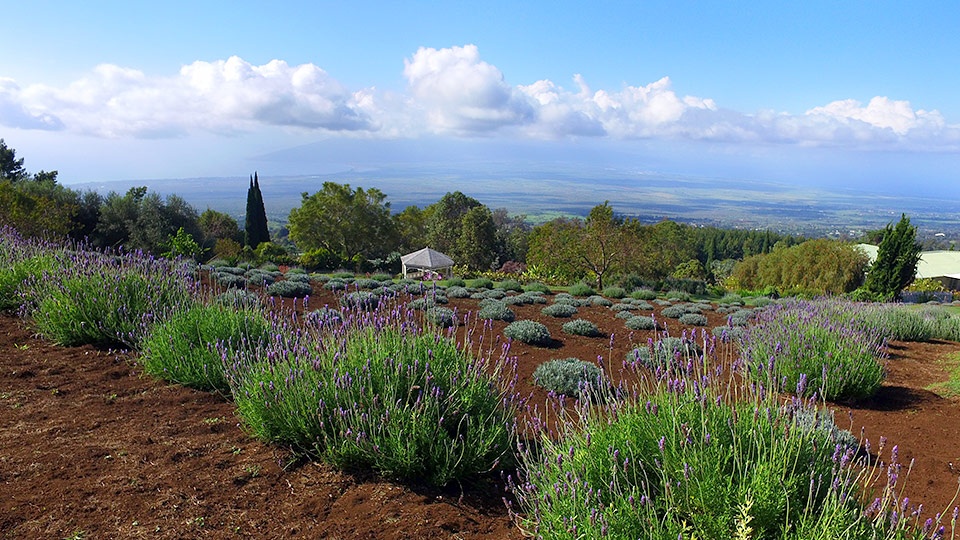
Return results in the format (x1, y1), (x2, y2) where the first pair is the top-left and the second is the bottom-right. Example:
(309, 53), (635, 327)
(0, 45), (960, 151)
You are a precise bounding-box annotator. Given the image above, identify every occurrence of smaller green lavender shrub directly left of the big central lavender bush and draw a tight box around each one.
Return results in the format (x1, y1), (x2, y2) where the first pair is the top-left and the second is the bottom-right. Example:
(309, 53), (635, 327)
(140, 305), (270, 394)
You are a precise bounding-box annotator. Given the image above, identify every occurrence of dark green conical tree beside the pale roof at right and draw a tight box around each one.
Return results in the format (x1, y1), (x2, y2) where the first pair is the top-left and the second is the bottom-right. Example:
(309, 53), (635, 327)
(866, 214), (922, 299)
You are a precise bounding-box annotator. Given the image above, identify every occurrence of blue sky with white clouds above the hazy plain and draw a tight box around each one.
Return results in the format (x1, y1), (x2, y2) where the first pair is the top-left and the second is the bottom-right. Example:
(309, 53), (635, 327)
(0, 0), (960, 198)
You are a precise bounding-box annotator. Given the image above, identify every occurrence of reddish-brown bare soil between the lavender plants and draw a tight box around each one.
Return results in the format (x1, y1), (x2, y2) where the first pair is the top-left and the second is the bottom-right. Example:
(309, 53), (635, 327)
(0, 290), (960, 540)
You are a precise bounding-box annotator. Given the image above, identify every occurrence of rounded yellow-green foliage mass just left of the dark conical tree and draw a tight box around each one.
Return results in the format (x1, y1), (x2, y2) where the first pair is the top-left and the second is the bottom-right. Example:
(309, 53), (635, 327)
(728, 239), (868, 295)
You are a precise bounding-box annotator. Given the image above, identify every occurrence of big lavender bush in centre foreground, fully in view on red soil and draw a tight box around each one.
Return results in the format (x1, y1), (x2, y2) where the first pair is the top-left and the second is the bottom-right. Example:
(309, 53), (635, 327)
(230, 321), (516, 486)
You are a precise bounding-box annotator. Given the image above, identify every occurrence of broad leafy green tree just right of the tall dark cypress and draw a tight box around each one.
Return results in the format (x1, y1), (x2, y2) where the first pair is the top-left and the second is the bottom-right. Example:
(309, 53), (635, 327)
(288, 182), (398, 260)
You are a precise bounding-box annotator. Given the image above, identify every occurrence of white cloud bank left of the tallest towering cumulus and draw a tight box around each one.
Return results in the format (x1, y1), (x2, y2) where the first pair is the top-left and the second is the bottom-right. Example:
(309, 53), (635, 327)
(3, 56), (373, 137)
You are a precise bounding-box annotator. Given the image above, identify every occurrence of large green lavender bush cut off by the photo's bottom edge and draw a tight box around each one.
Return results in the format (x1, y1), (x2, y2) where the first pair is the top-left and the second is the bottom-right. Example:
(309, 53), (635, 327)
(516, 372), (884, 540)
